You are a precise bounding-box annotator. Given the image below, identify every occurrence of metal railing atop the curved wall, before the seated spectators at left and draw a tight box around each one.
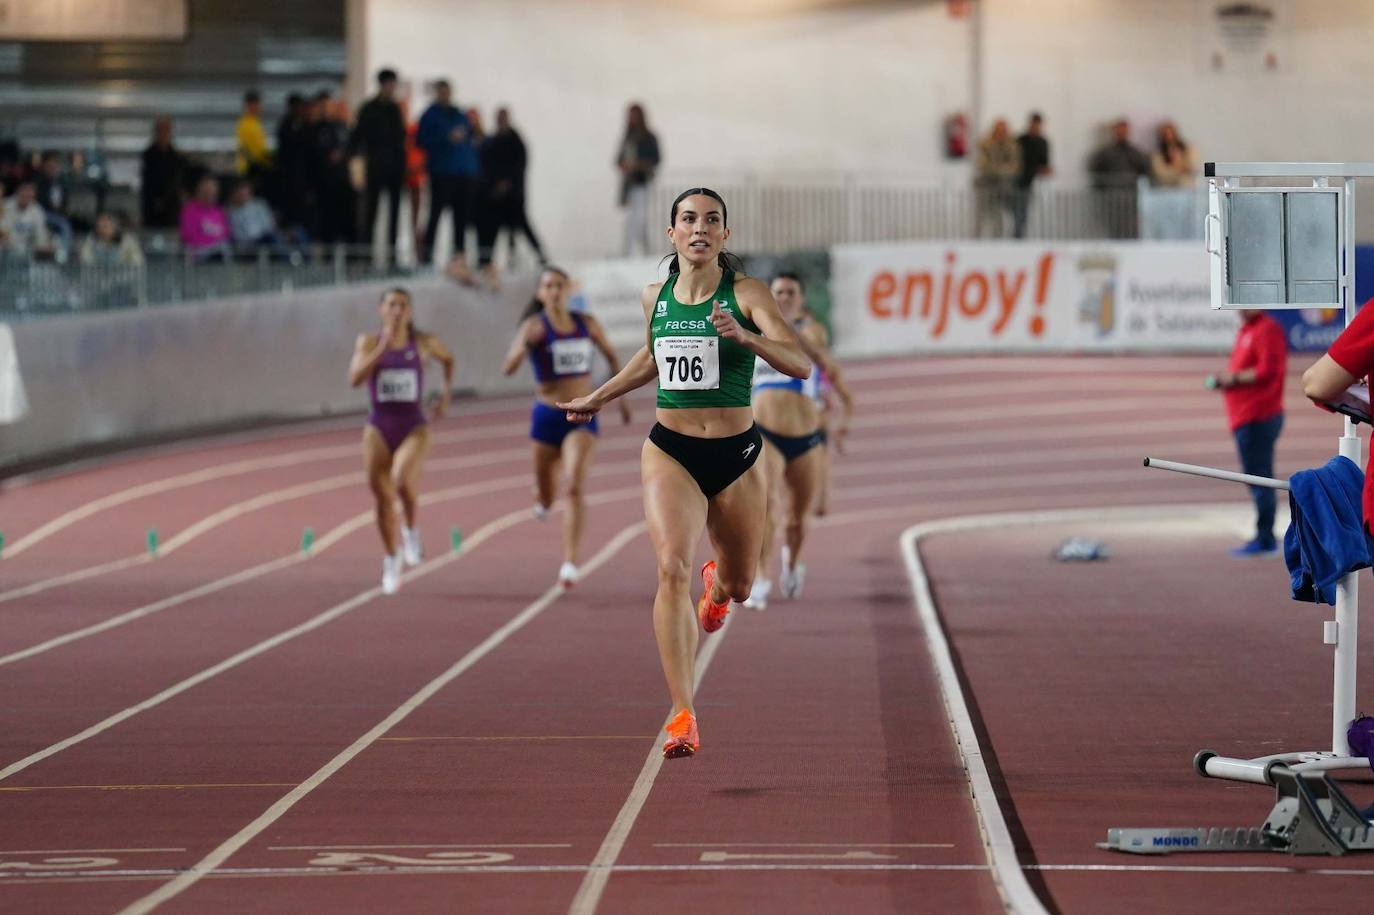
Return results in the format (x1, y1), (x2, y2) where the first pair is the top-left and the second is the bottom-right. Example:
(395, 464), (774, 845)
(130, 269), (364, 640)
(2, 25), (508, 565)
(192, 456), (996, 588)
(0, 245), (412, 321)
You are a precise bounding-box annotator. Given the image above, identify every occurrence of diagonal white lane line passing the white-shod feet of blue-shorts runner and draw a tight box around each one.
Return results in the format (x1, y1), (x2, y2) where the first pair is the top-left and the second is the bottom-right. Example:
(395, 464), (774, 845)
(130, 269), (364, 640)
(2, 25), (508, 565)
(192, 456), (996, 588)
(121, 512), (644, 915)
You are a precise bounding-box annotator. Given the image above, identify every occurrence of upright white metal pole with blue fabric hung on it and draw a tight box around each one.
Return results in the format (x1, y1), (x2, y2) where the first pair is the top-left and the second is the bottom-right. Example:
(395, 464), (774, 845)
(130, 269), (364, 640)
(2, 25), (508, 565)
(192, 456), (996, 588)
(1331, 177), (1363, 756)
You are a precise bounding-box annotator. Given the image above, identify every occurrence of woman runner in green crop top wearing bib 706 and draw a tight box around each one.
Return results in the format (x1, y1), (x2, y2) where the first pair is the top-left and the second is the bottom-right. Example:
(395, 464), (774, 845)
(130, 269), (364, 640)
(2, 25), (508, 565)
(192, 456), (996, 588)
(559, 188), (811, 758)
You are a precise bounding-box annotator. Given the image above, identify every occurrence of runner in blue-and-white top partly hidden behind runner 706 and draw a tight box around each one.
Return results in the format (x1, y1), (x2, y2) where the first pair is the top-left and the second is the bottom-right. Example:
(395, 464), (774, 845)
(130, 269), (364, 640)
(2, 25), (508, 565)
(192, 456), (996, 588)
(745, 273), (853, 610)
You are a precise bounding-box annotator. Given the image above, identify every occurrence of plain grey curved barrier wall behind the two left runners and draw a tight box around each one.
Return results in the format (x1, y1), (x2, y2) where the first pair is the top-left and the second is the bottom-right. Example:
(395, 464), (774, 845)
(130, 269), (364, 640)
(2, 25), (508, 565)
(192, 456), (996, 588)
(0, 276), (533, 467)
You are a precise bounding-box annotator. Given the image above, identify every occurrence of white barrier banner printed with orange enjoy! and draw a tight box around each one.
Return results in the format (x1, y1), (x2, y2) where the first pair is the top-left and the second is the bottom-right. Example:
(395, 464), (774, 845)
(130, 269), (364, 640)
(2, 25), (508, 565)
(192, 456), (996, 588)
(831, 242), (1237, 357)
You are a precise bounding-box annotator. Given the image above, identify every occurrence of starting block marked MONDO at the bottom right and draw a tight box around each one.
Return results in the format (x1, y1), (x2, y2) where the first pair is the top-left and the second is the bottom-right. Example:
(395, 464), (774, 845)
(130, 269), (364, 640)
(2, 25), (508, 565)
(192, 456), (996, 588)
(1098, 765), (1374, 856)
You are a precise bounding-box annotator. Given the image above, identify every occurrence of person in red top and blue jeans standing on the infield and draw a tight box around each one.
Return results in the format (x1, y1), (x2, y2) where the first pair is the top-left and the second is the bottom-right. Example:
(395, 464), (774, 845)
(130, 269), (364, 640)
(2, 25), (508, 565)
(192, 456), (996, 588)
(1213, 308), (1286, 559)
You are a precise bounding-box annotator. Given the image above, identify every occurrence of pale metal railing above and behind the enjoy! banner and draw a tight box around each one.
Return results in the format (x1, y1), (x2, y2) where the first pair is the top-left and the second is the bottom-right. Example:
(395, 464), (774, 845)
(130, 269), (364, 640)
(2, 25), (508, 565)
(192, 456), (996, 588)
(650, 176), (1206, 254)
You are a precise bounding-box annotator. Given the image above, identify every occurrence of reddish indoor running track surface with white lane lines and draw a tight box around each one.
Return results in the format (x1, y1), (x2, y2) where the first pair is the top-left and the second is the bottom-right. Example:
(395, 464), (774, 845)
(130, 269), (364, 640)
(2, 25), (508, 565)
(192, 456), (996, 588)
(0, 357), (1360, 912)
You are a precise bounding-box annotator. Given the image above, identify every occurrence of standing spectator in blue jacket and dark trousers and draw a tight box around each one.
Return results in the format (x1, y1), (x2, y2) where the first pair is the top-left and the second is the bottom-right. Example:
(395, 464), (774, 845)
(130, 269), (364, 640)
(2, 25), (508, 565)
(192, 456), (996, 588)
(415, 80), (478, 264)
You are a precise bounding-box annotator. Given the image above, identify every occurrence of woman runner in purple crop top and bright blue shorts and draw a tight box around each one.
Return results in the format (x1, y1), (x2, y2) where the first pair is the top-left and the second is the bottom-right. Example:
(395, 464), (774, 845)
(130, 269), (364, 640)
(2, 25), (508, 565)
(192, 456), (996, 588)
(503, 267), (631, 588)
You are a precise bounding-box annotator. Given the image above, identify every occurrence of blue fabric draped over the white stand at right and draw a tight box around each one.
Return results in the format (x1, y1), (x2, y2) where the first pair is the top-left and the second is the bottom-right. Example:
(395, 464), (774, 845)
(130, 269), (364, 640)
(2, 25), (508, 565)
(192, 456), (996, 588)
(1283, 458), (1374, 606)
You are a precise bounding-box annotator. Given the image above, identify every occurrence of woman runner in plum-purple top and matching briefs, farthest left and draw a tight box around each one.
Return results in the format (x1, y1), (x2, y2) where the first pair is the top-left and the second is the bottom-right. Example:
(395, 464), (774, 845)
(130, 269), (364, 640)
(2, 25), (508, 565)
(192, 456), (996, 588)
(349, 289), (453, 594)
